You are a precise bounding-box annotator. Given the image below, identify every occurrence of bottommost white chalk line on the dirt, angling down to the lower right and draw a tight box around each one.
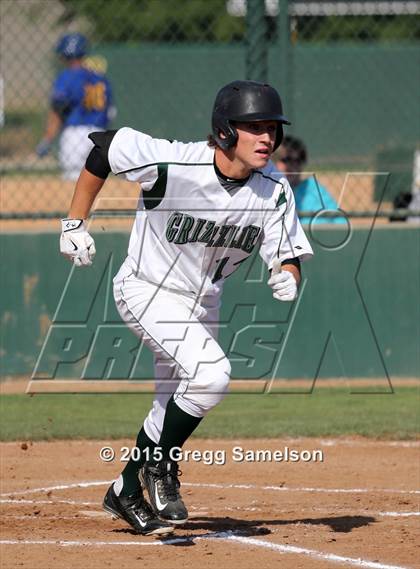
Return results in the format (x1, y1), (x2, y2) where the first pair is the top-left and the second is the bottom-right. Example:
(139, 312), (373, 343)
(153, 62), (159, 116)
(0, 531), (406, 569)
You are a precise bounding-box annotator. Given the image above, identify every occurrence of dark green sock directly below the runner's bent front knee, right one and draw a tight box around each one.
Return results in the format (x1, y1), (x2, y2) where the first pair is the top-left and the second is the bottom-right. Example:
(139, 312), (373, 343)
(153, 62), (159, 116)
(159, 395), (203, 460)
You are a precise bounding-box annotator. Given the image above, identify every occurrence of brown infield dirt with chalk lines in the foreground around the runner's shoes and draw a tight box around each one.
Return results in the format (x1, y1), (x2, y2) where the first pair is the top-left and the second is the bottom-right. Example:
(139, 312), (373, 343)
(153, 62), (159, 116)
(1, 438), (420, 569)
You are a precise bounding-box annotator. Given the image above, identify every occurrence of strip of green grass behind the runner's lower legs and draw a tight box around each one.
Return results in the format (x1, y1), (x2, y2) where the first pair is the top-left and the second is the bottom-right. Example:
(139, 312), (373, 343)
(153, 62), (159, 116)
(0, 387), (420, 440)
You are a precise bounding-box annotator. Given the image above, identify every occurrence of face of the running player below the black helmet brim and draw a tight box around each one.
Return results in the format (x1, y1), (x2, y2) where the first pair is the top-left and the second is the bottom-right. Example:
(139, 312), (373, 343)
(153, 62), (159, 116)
(234, 121), (277, 170)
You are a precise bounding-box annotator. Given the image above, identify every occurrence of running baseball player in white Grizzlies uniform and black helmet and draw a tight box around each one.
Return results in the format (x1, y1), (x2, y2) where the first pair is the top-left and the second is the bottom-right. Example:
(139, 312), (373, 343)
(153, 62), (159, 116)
(60, 81), (312, 535)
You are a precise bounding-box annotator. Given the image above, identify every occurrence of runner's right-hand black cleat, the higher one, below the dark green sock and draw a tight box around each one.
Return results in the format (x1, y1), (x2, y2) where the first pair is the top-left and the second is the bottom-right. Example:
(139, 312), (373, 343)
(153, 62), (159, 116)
(140, 460), (188, 524)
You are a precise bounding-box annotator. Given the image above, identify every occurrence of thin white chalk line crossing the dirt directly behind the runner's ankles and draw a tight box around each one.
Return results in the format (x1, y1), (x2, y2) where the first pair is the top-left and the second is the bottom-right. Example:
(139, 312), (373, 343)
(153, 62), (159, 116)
(0, 480), (420, 497)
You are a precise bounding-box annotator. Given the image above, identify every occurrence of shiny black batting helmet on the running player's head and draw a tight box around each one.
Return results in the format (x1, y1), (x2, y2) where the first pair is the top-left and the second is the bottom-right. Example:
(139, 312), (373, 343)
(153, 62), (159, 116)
(212, 81), (290, 150)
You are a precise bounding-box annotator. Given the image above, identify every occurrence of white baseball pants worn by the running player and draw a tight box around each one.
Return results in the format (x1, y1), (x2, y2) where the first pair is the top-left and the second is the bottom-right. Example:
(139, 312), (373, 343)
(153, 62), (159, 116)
(114, 264), (231, 443)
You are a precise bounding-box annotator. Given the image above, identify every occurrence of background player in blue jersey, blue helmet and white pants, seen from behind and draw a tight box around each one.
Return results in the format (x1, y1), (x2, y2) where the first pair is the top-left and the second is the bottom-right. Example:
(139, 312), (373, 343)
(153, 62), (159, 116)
(36, 33), (115, 180)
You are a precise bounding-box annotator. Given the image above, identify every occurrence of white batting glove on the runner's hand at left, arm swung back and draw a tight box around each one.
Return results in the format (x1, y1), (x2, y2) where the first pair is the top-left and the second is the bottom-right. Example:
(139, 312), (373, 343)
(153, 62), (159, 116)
(60, 219), (96, 267)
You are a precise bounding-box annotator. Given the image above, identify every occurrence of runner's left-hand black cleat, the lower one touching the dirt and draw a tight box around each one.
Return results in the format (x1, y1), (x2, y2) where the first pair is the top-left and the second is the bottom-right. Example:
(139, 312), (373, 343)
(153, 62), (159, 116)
(103, 484), (174, 535)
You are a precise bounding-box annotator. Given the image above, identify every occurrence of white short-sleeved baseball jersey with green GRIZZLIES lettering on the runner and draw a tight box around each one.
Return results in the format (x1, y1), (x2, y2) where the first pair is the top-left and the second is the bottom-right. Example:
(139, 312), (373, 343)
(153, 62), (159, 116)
(108, 128), (313, 296)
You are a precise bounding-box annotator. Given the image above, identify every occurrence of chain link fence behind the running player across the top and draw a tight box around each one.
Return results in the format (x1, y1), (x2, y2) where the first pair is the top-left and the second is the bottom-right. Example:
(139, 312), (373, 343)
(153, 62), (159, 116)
(0, 0), (420, 223)
